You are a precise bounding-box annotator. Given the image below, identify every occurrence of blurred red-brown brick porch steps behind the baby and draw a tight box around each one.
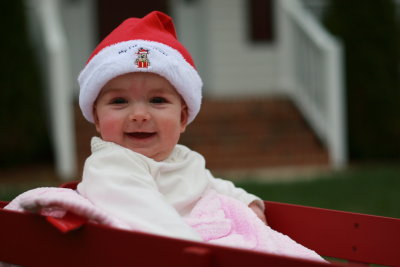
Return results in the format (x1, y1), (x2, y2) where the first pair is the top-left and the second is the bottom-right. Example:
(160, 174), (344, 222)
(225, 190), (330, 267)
(75, 98), (329, 175)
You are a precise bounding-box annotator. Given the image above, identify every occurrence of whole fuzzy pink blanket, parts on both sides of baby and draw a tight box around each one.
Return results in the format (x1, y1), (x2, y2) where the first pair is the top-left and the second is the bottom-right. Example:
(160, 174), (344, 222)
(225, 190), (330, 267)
(5, 187), (325, 262)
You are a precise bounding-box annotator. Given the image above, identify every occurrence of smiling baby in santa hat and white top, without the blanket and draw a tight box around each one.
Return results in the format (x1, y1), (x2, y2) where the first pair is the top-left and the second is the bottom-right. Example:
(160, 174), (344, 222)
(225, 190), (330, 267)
(77, 12), (265, 243)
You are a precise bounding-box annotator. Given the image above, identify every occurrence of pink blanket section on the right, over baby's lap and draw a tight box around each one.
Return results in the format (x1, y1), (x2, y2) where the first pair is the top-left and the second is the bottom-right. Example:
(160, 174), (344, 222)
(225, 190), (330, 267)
(187, 192), (326, 262)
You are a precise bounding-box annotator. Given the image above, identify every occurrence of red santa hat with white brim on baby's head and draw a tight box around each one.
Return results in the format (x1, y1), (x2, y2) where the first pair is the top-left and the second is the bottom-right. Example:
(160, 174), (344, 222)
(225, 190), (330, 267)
(78, 11), (203, 123)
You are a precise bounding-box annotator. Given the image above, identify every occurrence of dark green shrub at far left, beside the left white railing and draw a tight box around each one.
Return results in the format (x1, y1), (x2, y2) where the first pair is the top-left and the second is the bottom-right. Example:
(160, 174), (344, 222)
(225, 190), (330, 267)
(0, 0), (50, 167)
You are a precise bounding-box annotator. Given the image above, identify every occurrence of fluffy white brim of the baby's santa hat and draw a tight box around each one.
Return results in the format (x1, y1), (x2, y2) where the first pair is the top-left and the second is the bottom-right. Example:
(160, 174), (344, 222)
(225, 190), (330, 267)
(78, 40), (203, 123)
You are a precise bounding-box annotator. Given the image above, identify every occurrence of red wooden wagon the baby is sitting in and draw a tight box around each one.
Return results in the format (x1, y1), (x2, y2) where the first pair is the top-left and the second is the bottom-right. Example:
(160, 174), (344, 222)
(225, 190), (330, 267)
(0, 183), (400, 267)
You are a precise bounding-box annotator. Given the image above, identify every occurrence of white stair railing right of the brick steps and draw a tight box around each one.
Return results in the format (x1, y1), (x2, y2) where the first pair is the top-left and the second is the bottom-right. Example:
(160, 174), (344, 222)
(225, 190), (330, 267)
(276, 0), (347, 168)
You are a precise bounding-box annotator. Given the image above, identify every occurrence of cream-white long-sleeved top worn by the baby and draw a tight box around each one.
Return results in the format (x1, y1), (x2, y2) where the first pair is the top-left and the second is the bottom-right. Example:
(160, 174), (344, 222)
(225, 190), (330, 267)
(78, 137), (263, 240)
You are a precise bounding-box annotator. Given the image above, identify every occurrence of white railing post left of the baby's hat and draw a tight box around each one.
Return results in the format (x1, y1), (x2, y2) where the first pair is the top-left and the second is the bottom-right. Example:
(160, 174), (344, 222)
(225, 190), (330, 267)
(26, 0), (76, 180)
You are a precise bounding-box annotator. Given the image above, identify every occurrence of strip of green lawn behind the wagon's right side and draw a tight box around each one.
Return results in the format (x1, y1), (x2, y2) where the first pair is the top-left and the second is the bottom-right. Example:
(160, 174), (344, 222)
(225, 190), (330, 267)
(236, 166), (400, 218)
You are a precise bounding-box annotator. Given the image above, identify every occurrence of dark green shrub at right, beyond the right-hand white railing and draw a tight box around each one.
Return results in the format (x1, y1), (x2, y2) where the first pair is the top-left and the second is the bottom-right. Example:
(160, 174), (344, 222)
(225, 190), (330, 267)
(324, 0), (400, 160)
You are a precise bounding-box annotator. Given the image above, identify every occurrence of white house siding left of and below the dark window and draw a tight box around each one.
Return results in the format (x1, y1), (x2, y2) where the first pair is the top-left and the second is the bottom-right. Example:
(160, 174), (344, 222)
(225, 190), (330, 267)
(177, 0), (279, 97)
